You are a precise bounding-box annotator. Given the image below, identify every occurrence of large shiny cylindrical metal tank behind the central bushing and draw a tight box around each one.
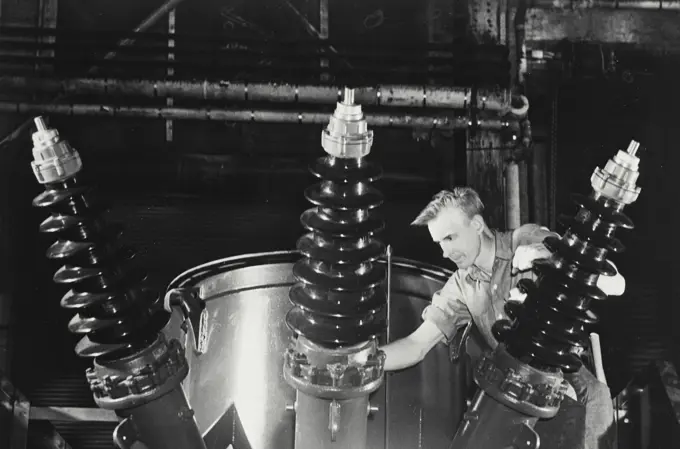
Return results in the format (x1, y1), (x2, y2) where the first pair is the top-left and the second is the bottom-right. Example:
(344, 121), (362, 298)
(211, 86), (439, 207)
(164, 250), (457, 449)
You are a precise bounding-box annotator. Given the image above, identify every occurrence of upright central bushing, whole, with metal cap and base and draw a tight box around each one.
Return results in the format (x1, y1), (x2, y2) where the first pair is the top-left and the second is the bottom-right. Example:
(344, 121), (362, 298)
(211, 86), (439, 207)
(284, 88), (387, 449)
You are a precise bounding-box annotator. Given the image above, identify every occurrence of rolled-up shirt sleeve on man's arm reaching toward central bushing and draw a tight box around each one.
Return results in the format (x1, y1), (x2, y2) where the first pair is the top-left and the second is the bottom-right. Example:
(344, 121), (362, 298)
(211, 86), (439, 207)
(422, 272), (471, 343)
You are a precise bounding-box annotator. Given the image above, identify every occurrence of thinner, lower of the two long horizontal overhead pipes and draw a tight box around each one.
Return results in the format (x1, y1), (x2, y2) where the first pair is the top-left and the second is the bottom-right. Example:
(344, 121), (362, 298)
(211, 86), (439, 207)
(0, 101), (520, 130)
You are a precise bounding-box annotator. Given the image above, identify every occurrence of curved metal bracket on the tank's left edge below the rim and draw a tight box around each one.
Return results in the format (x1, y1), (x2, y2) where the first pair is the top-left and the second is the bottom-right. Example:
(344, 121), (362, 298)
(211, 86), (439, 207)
(163, 287), (208, 354)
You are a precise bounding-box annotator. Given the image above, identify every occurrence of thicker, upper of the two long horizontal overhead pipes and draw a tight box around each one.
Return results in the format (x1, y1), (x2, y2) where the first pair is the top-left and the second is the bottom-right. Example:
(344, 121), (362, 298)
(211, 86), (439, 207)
(0, 76), (529, 116)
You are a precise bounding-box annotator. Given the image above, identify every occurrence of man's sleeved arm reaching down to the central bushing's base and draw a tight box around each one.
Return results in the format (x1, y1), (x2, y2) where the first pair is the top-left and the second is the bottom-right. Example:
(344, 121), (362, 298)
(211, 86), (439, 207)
(380, 272), (470, 371)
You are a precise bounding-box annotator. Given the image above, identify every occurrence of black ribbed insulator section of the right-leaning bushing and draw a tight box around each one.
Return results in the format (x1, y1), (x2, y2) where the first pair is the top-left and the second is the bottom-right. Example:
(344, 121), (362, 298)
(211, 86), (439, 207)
(494, 192), (633, 373)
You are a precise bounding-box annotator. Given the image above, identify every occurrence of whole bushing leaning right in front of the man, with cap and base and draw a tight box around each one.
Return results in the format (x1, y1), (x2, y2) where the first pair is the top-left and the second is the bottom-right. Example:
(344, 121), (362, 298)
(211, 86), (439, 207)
(451, 141), (640, 449)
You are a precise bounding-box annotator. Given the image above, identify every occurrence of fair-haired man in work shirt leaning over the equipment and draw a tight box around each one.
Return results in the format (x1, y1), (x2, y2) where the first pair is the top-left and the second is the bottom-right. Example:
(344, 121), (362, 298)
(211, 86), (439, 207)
(382, 187), (625, 449)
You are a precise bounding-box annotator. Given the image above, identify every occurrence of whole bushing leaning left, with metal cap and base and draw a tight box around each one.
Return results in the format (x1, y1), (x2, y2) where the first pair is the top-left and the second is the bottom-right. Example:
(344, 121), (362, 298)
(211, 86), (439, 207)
(27, 117), (205, 449)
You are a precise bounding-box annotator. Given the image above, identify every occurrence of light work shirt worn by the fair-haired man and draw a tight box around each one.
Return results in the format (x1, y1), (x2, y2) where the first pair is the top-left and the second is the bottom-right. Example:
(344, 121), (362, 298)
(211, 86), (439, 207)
(422, 224), (557, 349)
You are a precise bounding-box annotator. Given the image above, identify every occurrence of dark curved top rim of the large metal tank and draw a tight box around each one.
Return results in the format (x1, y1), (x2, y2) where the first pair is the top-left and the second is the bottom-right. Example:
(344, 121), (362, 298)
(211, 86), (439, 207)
(167, 250), (454, 290)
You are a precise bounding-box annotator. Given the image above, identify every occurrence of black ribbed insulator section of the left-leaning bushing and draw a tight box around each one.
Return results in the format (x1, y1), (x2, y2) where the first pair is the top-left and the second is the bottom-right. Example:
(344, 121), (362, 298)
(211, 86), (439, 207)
(33, 177), (168, 358)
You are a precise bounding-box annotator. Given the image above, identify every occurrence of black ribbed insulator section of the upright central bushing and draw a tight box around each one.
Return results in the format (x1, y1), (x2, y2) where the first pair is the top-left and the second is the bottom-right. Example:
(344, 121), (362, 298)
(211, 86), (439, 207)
(286, 156), (386, 347)
